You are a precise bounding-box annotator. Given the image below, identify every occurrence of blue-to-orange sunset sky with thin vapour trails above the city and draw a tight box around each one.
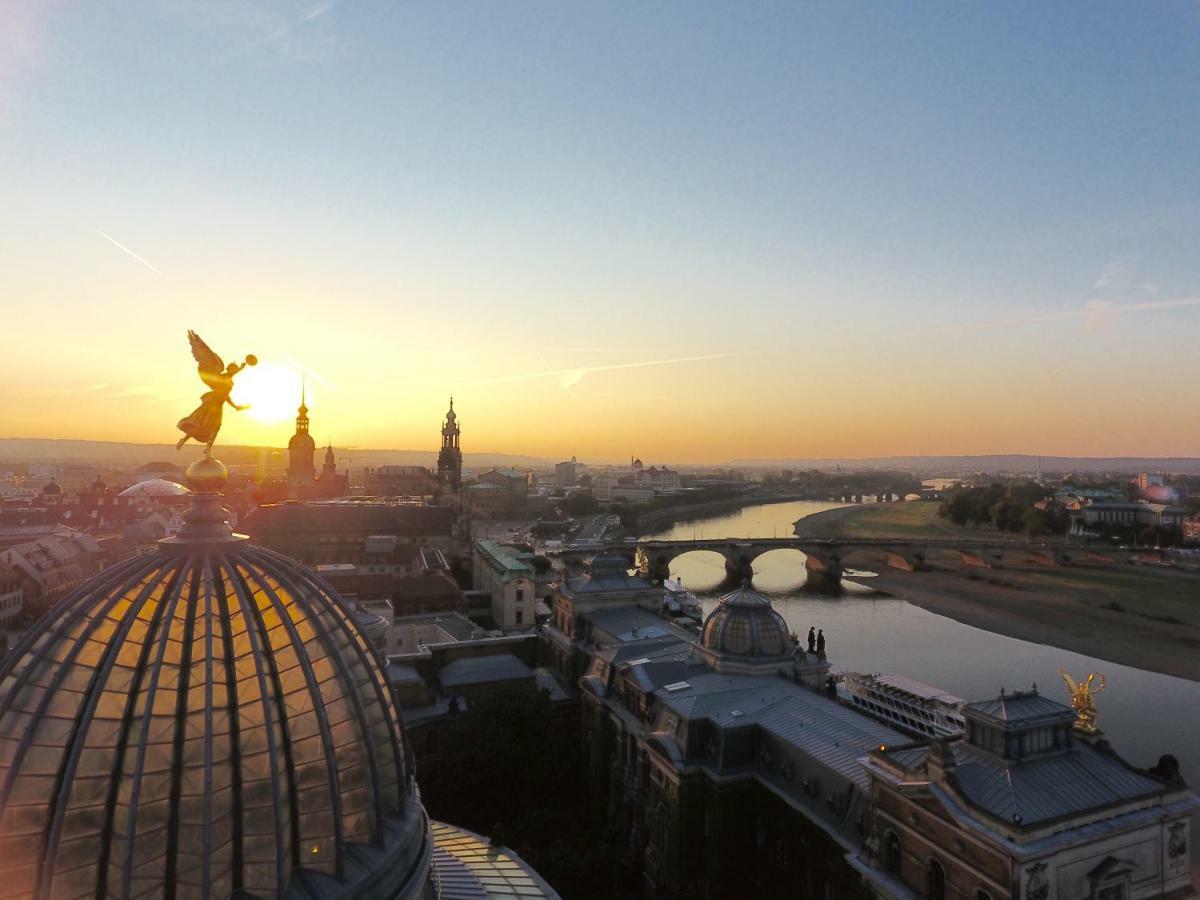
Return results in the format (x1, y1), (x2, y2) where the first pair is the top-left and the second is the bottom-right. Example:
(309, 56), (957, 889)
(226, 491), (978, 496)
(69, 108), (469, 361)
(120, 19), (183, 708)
(0, 0), (1200, 462)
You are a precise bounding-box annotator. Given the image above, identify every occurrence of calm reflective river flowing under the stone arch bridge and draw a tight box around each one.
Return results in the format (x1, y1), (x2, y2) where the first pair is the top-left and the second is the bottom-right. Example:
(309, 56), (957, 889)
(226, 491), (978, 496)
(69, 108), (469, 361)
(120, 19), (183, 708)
(643, 500), (1200, 785)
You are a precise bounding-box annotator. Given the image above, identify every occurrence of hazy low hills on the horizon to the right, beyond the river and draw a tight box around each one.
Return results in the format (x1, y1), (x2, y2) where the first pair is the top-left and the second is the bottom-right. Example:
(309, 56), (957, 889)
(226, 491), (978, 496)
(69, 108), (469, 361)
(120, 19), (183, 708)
(726, 454), (1200, 476)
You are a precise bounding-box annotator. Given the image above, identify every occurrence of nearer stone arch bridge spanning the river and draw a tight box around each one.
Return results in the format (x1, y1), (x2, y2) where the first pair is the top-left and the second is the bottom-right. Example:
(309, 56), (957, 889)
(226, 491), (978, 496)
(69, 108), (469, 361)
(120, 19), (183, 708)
(557, 538), (1129, 590)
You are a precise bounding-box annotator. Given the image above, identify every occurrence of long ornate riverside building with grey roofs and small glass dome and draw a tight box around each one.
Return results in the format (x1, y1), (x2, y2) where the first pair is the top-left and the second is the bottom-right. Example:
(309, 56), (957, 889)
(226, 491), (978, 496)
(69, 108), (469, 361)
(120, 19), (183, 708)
(544, 560), (1198, 900)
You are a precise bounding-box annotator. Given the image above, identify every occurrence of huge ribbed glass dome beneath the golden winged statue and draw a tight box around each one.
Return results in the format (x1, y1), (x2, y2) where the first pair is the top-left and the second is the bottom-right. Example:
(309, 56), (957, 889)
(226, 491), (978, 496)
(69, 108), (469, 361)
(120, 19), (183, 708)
(0, 540), (430, 898)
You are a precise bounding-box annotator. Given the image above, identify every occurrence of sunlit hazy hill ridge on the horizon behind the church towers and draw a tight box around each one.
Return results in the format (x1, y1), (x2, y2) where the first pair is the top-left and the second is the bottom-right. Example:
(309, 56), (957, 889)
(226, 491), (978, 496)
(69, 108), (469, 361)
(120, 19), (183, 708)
(0, 438), (557, 469)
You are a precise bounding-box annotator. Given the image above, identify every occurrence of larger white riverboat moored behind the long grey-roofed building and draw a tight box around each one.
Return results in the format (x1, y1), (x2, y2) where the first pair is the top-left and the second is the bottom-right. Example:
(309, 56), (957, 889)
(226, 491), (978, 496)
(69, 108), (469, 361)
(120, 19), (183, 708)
(836, 672), (966, 738)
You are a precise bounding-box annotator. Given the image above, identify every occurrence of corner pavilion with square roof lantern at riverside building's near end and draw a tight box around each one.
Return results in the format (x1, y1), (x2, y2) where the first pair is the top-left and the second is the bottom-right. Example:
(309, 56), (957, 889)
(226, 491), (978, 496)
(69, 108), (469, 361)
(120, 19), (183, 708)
(862, 689), (1198, 900)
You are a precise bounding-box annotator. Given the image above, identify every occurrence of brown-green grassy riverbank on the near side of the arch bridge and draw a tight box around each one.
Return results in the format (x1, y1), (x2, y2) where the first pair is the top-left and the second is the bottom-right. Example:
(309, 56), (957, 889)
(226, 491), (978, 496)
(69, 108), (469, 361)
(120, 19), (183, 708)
(848, 566), (1200, 682)
